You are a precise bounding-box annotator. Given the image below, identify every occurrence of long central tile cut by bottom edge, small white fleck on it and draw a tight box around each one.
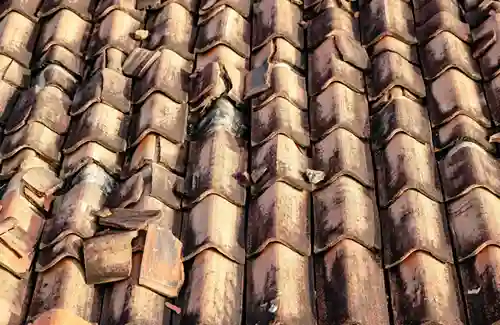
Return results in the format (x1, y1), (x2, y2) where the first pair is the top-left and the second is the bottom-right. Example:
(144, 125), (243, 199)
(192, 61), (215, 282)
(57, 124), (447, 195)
(246, 243), (316, 325)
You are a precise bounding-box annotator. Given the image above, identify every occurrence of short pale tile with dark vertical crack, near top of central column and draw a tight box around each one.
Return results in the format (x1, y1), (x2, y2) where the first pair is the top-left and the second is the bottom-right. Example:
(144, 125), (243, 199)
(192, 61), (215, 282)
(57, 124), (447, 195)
(252, 38), (307, 71)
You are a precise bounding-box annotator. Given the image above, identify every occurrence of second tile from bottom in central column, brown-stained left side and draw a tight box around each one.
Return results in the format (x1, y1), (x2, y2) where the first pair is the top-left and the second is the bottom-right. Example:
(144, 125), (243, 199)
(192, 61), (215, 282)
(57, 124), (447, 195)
(247, 181), (311, 259)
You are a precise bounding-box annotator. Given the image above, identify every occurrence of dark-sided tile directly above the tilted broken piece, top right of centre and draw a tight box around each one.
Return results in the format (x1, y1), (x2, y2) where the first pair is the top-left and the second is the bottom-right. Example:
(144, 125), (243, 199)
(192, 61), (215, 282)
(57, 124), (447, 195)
(307, 6), (360, 49)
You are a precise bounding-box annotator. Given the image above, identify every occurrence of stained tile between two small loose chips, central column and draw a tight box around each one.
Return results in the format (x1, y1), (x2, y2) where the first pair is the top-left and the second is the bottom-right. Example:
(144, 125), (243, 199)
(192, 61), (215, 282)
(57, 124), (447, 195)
(251, 134), (311, 196)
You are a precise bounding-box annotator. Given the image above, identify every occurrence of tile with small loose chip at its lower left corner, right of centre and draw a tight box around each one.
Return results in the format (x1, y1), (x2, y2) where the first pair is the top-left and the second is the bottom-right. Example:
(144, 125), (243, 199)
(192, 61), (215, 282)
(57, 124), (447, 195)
(312, 128), (375, 188)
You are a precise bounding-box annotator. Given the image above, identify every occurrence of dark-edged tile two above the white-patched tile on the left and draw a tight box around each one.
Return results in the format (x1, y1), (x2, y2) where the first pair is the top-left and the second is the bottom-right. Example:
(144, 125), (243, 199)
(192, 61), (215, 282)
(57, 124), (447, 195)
(64, 103), (129, 154)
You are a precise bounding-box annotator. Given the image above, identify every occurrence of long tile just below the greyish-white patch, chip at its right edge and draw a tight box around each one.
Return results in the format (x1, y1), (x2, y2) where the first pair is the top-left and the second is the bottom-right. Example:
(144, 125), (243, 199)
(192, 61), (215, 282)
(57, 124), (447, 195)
(185, 128), (247, 206)
